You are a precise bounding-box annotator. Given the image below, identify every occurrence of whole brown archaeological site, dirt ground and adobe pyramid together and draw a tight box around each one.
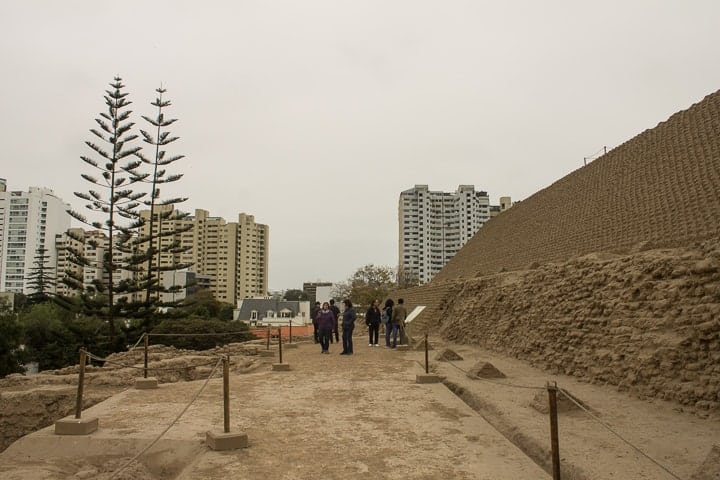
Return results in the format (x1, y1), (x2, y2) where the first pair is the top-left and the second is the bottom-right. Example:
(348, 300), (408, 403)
(0, 92), (720, 480)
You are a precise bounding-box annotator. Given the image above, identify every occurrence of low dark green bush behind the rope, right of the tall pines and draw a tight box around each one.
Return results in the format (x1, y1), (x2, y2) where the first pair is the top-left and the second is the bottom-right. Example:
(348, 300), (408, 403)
(150, 318), (254, 350)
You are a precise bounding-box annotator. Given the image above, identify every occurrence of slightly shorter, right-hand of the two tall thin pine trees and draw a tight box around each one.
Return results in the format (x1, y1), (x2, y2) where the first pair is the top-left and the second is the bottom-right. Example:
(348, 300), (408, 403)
(128, 86), (192, 307)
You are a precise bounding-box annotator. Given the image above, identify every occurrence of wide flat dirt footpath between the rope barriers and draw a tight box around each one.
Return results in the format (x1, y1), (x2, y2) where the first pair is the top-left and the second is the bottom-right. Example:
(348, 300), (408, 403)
(0, 336), (550, 480)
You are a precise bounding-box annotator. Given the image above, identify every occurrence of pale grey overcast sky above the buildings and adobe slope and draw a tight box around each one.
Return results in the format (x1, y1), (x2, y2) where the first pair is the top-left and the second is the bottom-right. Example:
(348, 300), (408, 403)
(0, 0), (720, 289)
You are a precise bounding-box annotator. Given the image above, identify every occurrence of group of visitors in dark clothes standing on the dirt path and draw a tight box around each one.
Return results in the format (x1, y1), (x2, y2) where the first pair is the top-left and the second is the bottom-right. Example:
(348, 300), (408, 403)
(310, 298), (407, 355)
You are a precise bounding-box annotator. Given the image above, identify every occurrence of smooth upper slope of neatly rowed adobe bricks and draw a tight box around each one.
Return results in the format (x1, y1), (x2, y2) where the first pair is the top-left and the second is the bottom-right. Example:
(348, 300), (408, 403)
(433, 92), (720, 282)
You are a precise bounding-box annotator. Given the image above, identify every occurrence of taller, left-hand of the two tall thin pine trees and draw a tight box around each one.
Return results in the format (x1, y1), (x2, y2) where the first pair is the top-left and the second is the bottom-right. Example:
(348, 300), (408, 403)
(68, 77), (145, 341)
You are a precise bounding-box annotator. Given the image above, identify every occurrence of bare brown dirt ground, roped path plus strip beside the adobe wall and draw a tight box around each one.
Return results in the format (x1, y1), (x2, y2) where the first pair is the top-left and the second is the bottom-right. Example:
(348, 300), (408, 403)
(0, 336), (720, 480)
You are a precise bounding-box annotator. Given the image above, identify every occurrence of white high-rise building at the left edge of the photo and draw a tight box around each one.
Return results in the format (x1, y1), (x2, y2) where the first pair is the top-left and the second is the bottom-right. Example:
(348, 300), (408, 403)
(0, 179), (70, 295)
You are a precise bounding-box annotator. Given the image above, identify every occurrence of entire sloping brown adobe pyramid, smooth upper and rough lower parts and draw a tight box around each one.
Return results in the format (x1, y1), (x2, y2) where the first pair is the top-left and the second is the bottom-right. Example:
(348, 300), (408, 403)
(394, 92), (720, 412)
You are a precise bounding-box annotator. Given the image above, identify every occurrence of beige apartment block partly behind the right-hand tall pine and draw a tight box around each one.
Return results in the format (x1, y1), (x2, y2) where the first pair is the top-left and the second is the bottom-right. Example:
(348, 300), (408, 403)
(140, 205), (270, 305)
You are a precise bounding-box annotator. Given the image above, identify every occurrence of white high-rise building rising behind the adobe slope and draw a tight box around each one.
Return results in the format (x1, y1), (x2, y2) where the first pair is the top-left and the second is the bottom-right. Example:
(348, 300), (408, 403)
(398, 185), (490, 284)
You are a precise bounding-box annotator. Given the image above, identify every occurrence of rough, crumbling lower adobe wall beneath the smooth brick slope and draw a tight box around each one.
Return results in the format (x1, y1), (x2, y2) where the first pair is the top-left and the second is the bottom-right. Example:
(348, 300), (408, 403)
(439, 240), (720, 415)
